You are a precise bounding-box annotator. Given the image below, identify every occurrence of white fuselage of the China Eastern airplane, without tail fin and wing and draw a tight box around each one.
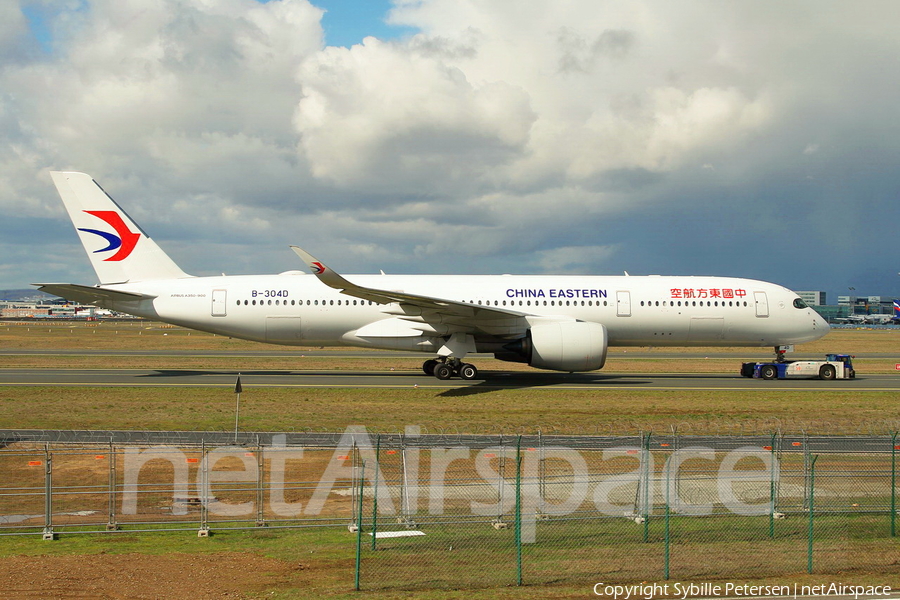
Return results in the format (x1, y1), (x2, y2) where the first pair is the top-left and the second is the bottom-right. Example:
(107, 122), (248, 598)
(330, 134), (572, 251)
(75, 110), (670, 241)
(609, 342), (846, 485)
(98, 271), (829, 352)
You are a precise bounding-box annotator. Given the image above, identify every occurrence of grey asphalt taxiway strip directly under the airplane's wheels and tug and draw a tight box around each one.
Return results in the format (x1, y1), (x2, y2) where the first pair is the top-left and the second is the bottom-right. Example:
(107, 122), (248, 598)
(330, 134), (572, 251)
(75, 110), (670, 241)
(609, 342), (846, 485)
(0, 368), (900, 393)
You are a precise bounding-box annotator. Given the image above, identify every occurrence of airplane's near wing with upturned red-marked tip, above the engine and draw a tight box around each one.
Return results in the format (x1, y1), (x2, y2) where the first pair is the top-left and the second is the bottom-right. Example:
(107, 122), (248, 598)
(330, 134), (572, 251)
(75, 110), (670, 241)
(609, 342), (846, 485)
(291, 246), (530, 338)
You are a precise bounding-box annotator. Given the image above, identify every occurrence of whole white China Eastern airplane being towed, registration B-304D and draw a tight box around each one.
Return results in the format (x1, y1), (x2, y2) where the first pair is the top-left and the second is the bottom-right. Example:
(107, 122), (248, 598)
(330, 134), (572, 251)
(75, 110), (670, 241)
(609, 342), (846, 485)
(33, 172), (830, 380)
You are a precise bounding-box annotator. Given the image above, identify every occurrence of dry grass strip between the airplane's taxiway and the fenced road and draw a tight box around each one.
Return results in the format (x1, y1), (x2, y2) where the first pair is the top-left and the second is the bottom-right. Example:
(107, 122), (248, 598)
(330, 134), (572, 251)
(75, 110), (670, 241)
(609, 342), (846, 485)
(0, 384), (900, 435)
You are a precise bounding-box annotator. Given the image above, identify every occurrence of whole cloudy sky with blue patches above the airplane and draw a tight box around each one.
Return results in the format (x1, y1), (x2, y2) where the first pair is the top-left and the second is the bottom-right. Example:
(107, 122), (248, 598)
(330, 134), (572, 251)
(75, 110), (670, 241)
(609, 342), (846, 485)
(0, 0), (900, 302)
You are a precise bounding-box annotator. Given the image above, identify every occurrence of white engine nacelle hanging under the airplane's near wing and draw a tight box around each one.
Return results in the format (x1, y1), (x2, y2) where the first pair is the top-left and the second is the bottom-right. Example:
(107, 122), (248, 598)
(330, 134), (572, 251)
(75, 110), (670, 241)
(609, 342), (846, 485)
(506, 321), (607, 373)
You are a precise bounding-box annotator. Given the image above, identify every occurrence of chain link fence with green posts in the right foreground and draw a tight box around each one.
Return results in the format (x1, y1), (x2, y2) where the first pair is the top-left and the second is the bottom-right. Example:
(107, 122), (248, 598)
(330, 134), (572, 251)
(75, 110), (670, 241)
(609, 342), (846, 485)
(354, 435), (900, 590)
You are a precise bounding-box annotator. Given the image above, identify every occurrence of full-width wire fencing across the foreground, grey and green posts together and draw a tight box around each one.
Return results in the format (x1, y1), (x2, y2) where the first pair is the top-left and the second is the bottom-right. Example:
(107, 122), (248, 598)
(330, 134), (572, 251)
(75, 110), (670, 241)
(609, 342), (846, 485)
(0, 428), (900, 590)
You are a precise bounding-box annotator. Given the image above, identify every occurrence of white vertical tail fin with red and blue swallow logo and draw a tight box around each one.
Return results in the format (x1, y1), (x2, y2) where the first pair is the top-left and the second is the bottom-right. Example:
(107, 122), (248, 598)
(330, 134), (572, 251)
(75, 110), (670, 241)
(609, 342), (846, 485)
(50, 171), (190, 284)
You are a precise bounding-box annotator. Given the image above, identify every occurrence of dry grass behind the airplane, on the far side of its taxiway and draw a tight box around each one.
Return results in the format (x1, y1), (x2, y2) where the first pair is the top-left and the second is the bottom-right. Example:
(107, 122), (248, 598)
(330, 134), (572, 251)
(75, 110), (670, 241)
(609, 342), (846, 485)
(0, 321), (900, 374)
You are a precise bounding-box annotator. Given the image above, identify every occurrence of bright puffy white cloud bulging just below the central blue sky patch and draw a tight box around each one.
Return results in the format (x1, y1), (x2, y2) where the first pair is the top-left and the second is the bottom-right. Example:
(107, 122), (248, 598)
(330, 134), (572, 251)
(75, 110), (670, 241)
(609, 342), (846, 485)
(295, 37), (534, 194)
